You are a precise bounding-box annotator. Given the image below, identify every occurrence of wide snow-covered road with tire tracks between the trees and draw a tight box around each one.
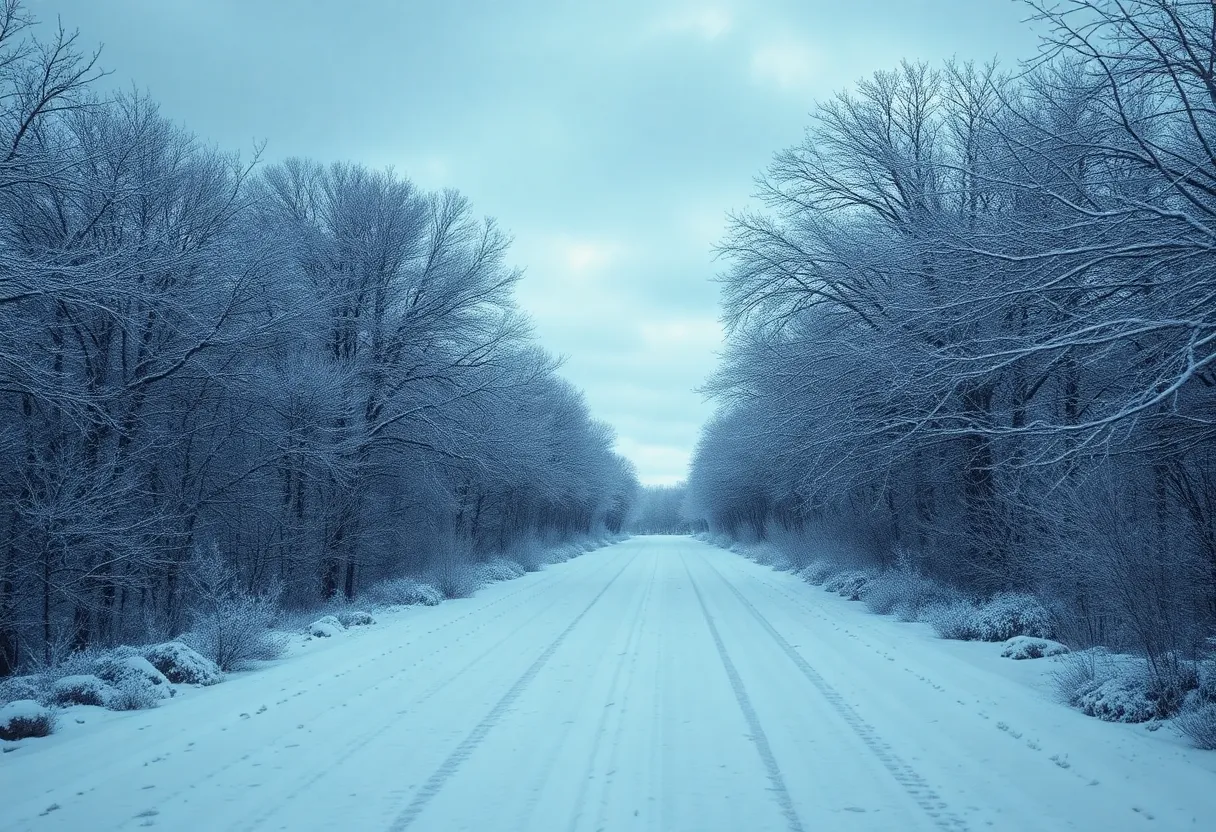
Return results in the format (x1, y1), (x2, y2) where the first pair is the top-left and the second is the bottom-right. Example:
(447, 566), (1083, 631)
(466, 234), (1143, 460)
(0, 536), (1216, 832)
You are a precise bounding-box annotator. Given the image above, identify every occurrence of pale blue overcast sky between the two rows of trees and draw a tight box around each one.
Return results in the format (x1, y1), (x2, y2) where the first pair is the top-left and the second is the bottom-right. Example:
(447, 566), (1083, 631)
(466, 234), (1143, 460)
(38, 0), (1034, 483)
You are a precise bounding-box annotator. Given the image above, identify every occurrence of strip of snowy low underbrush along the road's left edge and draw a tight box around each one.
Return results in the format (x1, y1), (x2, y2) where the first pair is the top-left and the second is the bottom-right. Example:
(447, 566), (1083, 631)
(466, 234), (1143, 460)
(0, 534), (626, 742)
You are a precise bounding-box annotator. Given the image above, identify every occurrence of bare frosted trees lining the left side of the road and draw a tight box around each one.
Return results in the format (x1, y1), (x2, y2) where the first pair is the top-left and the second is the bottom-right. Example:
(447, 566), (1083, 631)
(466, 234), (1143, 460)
(0, 0), (636, 675)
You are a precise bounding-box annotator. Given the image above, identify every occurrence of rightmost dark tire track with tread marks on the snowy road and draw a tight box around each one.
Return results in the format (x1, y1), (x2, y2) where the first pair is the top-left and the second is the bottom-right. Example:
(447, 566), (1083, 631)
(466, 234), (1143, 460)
(700, 552), (968, 832)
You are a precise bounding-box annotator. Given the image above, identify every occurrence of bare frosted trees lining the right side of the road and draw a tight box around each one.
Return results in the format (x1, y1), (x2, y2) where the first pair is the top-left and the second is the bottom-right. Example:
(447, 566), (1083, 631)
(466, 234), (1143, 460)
(689, 0), (1216, 674)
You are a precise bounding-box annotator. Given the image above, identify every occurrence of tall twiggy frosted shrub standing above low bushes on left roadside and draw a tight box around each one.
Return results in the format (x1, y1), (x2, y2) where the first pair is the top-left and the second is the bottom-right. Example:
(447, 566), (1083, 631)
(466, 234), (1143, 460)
(181, 549), (287, 671)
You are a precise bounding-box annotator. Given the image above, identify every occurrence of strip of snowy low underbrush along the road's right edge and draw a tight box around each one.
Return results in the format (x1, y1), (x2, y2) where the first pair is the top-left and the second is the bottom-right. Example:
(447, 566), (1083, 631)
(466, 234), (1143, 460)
(697, 534), (1216, 749)
